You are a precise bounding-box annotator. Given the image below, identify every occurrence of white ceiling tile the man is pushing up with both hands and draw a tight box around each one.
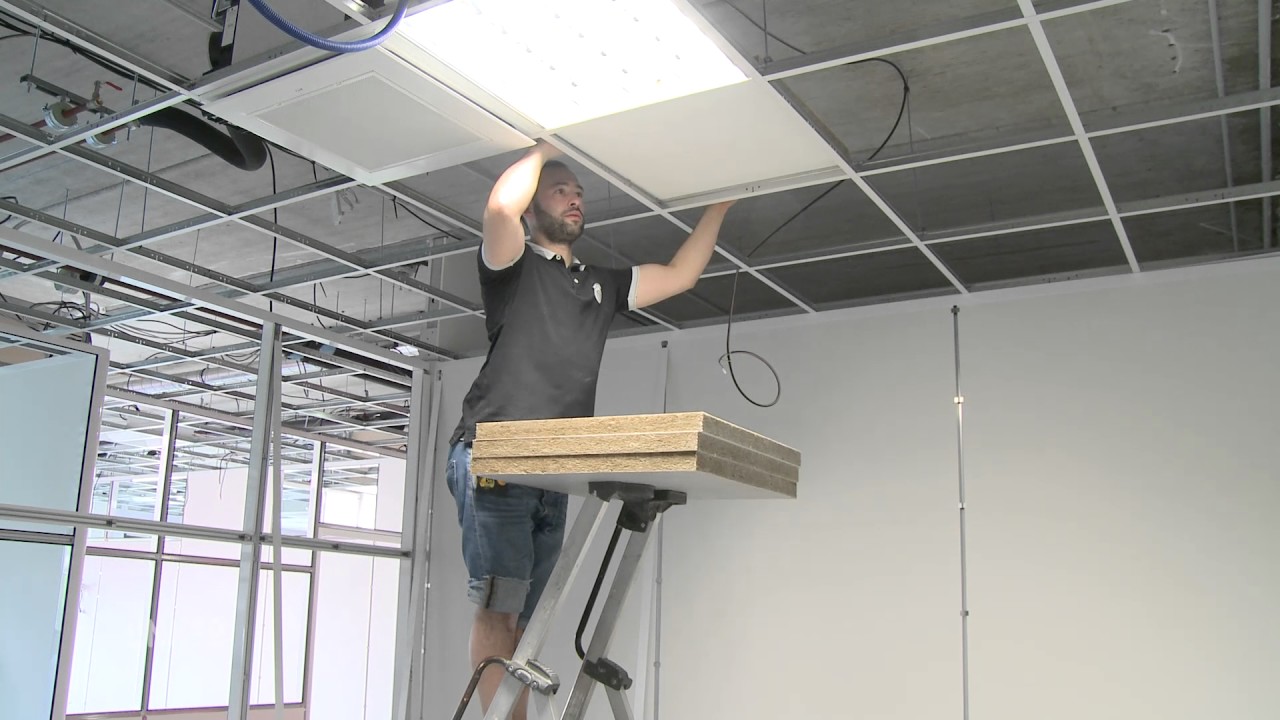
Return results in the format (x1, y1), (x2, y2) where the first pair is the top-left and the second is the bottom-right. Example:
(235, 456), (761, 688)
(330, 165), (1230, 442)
(559, 82), (835, 202)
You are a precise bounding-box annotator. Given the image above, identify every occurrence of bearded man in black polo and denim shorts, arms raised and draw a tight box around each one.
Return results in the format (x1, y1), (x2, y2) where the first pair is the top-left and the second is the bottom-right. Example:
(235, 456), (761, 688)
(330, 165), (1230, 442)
(445, 141), (732, 720)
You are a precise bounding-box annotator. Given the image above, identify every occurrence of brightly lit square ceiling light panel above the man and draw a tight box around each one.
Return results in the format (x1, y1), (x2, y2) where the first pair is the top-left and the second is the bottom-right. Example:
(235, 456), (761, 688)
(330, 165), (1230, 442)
(401, 0), (746, 129)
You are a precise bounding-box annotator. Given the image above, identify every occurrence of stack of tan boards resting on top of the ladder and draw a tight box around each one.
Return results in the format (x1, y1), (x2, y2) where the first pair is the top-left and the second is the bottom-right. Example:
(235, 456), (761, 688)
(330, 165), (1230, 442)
(471, 413), (800, 501)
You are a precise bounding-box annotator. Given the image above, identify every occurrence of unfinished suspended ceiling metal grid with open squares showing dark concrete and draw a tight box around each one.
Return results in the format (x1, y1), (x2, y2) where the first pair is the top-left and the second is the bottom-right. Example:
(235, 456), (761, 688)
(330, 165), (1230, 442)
(0, 0), (1280, 447)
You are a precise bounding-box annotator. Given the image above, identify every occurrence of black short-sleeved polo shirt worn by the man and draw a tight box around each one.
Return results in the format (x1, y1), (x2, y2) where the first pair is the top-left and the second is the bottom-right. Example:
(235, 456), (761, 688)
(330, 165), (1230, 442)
(451, 242), (637, 442)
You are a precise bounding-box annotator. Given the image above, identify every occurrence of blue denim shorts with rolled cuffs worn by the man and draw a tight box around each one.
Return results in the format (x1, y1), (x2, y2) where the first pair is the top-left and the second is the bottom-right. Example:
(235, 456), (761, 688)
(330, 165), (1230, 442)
(444, 442), (568, 628)
